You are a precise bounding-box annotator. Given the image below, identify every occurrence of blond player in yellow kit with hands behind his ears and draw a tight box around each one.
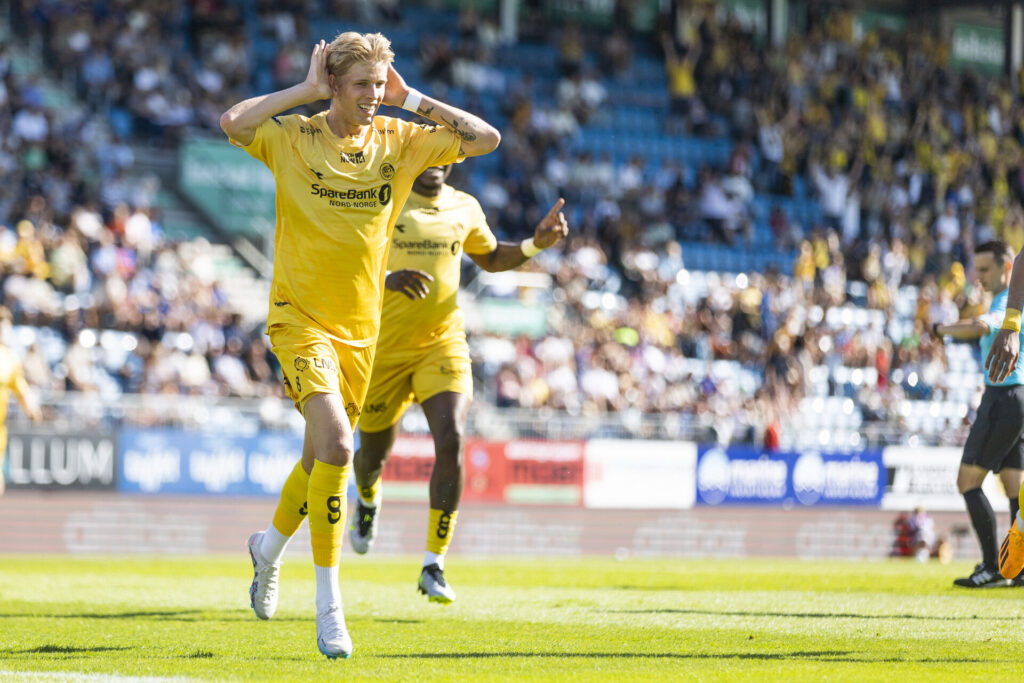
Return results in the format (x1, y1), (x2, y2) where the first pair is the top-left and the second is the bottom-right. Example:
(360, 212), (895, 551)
(220, 33), (501, 658)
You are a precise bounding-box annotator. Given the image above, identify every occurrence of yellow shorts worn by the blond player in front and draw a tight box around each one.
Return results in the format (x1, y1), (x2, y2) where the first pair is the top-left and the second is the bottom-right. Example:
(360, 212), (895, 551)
(267, 323), (375, 429)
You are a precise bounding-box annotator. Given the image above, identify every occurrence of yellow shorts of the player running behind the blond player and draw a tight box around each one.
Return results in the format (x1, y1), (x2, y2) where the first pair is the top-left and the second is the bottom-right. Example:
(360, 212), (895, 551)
(359, 337), (473, 432)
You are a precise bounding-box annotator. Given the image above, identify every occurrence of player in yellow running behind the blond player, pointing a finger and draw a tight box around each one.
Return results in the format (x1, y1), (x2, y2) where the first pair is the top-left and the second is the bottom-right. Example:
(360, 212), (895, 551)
(349, 166), (568, 604)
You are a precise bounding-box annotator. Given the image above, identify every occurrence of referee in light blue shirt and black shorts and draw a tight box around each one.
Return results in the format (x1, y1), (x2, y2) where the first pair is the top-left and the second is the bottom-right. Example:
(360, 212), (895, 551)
(932, 240), (1024, 588)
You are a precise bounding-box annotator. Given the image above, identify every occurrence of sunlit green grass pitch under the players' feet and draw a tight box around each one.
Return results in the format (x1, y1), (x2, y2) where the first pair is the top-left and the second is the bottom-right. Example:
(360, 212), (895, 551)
(0, 549), (1024, 682)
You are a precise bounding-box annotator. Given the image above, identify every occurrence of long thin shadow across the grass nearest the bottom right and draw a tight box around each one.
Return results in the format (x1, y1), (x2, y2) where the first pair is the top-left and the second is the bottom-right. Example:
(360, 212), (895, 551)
(377, 650), (1017, 664)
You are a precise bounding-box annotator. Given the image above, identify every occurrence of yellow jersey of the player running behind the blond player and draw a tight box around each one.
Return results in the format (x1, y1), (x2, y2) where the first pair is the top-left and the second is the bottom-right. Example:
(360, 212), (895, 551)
(377, 185), (498, 356)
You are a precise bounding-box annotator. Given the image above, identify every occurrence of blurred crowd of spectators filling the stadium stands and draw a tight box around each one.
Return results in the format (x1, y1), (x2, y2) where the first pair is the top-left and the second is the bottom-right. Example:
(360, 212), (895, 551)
(0, 0), (1011, 443)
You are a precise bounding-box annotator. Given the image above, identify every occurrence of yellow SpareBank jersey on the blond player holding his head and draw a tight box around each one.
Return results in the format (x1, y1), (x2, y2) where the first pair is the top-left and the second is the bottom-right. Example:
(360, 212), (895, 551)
(232, 112), (461, 348)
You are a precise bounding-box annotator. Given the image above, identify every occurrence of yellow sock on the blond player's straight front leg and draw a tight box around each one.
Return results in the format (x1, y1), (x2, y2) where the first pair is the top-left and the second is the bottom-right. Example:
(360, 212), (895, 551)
(306, 460), (350, 567)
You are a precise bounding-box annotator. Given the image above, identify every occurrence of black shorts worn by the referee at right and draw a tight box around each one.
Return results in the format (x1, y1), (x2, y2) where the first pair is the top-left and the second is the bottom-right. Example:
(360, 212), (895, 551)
(961, 384), (1024, 472)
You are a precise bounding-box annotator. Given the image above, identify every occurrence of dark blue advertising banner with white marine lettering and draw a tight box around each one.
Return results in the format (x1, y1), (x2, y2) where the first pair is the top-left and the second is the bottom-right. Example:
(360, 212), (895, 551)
(697, 446), (886, 506)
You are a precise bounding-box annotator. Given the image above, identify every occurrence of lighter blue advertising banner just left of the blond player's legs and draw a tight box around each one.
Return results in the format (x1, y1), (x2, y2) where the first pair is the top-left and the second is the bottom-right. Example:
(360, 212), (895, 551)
(118, 429), (302, 496)
